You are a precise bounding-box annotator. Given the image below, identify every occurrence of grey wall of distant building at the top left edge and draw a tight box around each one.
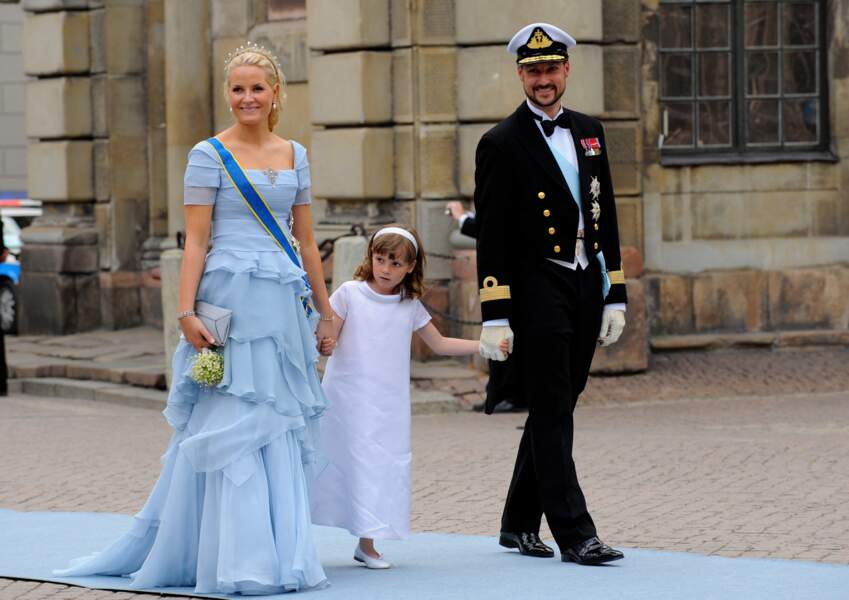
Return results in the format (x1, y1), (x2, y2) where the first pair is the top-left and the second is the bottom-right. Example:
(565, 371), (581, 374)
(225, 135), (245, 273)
(0, 3), (27, 192)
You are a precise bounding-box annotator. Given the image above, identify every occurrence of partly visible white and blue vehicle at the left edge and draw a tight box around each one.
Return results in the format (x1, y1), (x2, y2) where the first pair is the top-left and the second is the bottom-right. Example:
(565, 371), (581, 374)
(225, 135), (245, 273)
(0, 199), (41, 333)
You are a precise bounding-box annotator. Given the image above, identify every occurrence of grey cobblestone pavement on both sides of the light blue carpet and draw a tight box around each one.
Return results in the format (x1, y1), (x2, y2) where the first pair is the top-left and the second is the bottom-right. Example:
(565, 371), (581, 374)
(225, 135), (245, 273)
(0, 349), (849, 600)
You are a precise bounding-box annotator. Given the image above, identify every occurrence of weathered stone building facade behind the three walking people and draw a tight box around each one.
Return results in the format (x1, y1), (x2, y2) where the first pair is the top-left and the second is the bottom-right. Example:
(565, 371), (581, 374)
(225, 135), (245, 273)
(8, 0), (849, 369)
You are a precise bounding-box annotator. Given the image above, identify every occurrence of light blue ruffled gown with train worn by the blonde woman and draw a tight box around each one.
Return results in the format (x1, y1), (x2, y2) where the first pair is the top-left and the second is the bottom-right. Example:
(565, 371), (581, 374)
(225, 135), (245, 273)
(57, 142), (326, 594)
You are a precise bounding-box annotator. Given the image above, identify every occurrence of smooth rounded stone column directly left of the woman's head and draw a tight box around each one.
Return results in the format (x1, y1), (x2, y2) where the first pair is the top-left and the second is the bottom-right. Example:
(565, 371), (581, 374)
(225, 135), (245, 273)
(164, 0), (212, 239)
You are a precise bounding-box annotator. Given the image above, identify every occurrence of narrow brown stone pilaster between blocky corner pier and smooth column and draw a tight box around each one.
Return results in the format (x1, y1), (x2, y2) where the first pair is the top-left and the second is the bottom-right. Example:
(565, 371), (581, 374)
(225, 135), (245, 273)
(91, 0), (150, 329)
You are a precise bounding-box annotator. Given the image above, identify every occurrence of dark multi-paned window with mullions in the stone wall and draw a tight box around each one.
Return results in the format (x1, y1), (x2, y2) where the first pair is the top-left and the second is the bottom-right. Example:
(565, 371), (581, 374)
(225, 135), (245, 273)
(658, 0), (826, 154)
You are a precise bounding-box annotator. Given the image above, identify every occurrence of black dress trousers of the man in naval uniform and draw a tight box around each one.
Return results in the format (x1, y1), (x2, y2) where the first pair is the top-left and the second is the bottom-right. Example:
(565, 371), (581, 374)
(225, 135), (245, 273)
(501, 259), (604, 552)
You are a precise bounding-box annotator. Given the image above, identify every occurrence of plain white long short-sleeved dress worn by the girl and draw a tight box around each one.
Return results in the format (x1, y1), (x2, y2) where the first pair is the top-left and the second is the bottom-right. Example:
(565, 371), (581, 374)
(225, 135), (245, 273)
(310, 281), (430, 539)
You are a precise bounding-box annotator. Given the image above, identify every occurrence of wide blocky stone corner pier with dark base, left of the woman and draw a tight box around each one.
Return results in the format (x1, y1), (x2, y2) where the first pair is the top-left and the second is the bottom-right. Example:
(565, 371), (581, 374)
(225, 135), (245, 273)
(21, 0), (157, 333)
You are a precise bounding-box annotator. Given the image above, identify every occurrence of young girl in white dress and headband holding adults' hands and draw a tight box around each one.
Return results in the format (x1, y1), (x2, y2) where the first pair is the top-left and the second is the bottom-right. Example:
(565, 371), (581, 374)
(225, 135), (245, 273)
(311, 225), (496, 569)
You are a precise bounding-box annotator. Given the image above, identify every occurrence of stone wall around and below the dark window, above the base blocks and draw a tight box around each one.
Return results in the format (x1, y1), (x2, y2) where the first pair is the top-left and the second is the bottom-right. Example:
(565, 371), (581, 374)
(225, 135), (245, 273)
(642, 0), (849, 273)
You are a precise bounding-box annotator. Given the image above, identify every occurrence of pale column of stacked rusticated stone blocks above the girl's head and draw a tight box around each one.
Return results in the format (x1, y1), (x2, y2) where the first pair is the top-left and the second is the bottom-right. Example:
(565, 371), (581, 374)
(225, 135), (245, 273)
(307, 0), (395, 241)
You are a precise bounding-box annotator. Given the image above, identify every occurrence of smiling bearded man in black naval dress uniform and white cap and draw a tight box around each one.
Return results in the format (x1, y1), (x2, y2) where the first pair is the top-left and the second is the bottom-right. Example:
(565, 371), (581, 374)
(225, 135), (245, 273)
(475, 23), (627, 564)
